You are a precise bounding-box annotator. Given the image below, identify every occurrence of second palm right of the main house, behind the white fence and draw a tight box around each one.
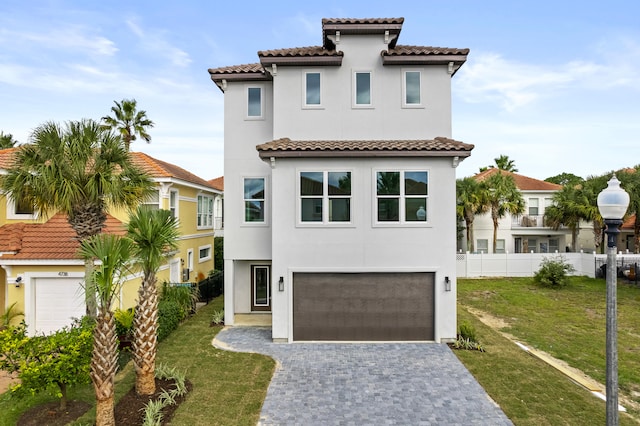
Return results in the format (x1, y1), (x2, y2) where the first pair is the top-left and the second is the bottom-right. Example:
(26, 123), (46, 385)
(481, 171), (524, 253)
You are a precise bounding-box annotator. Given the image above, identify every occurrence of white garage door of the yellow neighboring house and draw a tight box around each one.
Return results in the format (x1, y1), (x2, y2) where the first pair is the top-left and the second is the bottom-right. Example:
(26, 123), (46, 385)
(33, 278), (86, 334)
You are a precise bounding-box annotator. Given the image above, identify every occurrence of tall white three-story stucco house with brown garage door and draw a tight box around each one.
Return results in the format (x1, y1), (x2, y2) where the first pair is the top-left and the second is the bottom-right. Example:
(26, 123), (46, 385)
(209, 18), (473, 342)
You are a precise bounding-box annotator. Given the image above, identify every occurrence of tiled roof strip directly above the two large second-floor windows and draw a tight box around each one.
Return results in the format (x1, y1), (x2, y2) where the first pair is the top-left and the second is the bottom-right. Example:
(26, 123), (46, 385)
(256, 137), (473, 158)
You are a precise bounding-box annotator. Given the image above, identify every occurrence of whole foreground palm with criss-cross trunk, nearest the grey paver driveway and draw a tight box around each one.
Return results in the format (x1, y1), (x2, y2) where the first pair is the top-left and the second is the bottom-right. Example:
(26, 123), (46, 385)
(127, 207), (179, 395)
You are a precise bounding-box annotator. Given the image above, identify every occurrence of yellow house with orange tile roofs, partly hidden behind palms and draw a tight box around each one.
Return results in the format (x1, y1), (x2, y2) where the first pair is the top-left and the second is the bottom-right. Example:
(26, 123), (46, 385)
(0, 148), (221, 334)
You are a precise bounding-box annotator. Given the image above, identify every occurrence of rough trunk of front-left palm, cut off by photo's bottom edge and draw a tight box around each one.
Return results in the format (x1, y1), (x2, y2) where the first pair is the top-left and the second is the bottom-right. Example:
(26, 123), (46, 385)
(90, 309), (118, 426)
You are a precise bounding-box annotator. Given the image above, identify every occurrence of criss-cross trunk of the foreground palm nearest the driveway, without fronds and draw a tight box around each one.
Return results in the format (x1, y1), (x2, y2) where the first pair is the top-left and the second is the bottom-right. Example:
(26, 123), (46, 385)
(133, 274), (158, 395)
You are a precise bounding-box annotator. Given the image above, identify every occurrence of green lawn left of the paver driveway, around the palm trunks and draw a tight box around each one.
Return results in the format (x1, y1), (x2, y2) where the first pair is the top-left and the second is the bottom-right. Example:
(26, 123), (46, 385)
(0, 297), (275, 426)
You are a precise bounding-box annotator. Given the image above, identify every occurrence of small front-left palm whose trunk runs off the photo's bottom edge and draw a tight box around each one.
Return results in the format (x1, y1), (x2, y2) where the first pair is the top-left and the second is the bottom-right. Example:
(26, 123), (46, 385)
(80, 234), (133, 426)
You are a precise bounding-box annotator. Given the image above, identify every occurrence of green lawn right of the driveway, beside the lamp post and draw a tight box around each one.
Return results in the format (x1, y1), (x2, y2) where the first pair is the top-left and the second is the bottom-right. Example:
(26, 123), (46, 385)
(455, 277), (640, 425)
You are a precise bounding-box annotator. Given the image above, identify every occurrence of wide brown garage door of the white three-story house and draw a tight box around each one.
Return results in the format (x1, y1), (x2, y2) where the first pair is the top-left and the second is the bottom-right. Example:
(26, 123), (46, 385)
(293, 273), (434, 341)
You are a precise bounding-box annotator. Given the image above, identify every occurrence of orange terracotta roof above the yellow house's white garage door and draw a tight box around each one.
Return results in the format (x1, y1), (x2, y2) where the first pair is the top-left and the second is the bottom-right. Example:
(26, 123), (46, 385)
(0, 213), (125, 261)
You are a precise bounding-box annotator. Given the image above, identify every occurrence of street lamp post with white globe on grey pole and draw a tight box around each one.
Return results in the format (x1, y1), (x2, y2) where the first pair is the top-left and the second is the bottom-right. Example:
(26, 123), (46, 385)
(598, 175), (629, 426)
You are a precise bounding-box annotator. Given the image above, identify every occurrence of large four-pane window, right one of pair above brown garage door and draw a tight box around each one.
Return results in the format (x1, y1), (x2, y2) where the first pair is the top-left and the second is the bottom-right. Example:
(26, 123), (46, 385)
(376, 170), (429, 223)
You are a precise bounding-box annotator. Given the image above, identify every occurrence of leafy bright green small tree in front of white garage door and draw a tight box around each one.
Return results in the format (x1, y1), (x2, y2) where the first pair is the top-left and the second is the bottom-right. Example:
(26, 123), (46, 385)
(0, 320), (93, 411)
